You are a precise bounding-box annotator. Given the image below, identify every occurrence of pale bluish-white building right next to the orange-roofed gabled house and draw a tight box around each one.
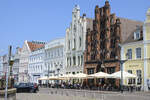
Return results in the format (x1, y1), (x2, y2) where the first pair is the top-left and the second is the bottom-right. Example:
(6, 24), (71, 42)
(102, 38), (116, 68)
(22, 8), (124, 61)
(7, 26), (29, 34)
(28, 47), (45, 83)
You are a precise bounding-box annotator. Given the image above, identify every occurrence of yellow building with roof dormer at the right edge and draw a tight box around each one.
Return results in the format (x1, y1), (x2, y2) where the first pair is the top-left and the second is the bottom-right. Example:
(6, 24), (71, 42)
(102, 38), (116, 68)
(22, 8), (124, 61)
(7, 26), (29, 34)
(121, 9), (150, 91)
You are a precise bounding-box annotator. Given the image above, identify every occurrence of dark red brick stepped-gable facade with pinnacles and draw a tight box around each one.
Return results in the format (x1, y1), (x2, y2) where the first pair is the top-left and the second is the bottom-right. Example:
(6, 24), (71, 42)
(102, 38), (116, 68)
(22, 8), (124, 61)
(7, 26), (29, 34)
(84, 1), (121, 84)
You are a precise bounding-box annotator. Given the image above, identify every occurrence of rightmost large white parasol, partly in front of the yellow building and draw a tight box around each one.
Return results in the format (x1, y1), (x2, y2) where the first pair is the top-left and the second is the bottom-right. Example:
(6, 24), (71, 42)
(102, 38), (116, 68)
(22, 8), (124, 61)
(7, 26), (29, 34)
(110, 71), (137, 79)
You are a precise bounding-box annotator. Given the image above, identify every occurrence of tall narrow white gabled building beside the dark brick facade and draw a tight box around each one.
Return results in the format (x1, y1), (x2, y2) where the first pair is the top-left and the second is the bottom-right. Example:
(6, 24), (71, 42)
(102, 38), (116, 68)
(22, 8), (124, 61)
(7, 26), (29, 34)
(65, 6), (93, 74)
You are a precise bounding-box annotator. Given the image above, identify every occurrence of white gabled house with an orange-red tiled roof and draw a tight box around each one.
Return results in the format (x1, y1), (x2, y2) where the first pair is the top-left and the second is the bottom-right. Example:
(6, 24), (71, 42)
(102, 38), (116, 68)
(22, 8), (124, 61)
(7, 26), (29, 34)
(19, 40), (44, 82)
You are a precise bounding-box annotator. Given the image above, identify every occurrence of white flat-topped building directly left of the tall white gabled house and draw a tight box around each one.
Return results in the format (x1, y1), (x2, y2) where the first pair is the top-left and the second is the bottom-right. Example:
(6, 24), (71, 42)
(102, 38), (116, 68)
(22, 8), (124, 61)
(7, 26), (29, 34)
(45, 38), (65, 76)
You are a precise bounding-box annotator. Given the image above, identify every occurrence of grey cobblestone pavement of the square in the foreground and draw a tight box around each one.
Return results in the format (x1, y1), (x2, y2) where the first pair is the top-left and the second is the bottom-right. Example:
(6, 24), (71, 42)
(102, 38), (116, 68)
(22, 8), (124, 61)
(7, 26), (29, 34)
(17, 88), (150, 100)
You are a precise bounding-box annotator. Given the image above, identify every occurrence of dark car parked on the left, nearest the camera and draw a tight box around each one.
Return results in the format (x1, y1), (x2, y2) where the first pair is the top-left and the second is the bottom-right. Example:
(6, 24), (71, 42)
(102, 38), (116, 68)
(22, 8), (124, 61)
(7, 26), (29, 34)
(14, 83), (37, 93)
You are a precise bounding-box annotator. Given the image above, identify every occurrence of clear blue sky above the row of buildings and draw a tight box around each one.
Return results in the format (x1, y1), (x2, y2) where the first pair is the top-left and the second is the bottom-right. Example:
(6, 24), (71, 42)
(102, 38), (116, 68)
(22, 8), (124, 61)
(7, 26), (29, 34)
(0, 0), (150, 55)
